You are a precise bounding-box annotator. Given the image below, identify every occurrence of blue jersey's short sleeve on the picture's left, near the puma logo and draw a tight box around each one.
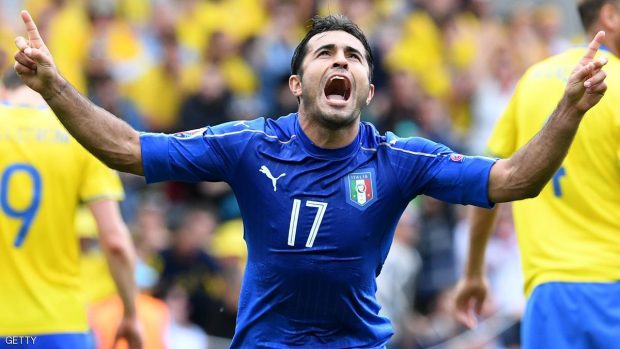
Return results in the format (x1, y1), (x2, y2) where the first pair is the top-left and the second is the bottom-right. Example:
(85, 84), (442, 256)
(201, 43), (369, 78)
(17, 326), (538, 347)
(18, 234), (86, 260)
(140, 119), (264, 183)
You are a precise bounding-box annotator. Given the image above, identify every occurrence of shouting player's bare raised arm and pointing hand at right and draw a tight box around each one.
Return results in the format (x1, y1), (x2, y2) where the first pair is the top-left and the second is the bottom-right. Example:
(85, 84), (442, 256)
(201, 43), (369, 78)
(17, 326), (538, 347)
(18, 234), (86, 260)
(489, 31), (607, 202)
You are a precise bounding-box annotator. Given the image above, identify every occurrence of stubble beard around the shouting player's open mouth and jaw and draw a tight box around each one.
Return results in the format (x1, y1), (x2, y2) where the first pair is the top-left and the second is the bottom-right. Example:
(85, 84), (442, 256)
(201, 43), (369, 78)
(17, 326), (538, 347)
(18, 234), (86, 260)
(299, 76), (370, 131)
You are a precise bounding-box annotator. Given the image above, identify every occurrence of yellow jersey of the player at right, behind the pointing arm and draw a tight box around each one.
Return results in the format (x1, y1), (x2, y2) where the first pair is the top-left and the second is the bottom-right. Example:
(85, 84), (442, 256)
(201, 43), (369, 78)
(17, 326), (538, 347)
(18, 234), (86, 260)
(489, 48), (620, 296)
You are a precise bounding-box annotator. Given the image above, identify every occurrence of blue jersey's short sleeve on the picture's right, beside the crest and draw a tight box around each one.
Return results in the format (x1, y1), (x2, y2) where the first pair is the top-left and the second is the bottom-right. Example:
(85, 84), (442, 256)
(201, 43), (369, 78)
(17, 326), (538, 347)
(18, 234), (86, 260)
(390, 137), (496, 208)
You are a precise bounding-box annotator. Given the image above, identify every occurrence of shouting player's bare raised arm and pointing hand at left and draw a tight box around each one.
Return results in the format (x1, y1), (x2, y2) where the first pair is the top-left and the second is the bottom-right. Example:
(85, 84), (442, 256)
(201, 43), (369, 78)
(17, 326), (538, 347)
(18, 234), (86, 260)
(14, 11), (143, 175)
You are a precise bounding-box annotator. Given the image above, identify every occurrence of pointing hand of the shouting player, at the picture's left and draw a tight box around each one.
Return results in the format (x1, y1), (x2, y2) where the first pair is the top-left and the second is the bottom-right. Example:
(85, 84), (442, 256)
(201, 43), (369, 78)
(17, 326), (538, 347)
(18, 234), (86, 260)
(14, 11), (62, 99)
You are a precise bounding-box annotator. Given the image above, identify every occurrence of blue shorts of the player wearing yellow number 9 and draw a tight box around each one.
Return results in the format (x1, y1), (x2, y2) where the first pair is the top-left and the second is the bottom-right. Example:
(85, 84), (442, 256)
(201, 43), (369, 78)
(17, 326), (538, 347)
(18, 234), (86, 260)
(0, 332), (95, 349)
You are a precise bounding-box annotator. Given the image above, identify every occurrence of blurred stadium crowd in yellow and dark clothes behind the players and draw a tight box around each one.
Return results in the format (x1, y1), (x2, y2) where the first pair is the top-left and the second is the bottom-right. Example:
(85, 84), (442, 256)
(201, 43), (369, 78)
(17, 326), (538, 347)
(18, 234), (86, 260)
(0, 0), (570, 349)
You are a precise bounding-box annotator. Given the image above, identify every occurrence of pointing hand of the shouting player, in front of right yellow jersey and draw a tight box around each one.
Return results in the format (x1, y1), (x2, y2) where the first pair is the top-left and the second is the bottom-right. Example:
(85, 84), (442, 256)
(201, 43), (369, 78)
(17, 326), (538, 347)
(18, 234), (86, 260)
(564, 31), (607, 113)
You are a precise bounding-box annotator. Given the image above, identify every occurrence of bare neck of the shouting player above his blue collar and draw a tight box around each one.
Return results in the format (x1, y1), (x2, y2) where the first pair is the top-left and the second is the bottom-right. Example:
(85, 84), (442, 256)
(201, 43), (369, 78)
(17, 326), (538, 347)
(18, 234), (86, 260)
(299, 111), (360, 149)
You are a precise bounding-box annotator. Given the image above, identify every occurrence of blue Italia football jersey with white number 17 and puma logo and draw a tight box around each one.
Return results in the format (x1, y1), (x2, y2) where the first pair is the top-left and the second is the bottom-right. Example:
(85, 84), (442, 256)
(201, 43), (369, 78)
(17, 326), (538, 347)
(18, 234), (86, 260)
(141, 114), (495, 348)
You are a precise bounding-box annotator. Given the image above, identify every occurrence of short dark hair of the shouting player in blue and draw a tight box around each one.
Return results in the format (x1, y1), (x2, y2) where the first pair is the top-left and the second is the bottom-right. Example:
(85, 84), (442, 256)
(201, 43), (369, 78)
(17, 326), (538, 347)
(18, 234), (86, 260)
(291, 15), (374, 81)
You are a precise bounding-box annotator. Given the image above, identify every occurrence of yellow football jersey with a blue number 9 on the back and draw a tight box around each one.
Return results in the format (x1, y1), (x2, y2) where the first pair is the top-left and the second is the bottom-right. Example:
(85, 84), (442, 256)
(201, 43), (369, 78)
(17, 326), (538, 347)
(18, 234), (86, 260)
(0, 105), (123, 336)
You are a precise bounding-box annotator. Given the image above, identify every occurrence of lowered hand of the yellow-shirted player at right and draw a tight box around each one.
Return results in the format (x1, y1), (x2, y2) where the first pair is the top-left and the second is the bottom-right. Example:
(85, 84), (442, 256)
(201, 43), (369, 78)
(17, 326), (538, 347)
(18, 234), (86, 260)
(454, 277), (489, 328)
